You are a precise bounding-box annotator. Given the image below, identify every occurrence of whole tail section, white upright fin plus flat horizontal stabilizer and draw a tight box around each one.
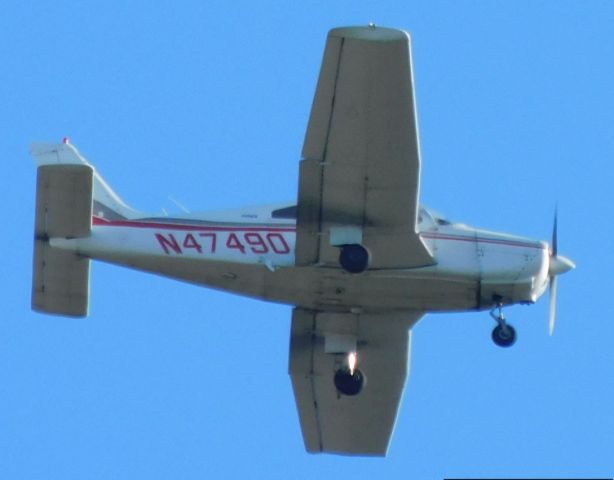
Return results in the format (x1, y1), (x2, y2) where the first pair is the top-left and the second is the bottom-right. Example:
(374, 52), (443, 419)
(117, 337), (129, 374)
(32, 142), (142, 317)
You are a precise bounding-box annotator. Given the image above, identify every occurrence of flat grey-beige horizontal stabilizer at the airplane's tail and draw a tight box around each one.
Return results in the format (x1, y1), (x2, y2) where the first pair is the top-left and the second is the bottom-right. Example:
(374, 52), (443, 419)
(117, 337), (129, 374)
(32, 165), (93, 316)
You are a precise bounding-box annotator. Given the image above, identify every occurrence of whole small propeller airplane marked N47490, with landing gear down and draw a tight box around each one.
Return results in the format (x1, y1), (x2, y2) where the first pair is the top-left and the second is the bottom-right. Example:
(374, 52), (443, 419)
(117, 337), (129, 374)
(32, 25), (575, 455)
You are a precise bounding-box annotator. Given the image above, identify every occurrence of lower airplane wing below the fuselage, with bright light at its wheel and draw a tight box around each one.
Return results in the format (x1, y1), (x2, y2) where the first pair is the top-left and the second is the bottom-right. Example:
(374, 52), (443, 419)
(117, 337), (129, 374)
(289, 308), (422, 456)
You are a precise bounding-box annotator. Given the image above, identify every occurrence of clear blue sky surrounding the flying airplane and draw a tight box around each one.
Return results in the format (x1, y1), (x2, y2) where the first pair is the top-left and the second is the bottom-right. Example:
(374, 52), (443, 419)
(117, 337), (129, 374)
(0, 0), (614, 479)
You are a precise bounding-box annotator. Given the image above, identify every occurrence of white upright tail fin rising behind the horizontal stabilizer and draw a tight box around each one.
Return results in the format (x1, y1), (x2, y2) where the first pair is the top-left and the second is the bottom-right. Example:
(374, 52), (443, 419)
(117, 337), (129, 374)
(32, 142), (142, 220)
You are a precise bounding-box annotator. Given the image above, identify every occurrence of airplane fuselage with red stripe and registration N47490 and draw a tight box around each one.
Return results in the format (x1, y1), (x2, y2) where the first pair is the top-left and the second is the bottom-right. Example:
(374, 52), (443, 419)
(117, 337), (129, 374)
(50, 202), (548, 311)
